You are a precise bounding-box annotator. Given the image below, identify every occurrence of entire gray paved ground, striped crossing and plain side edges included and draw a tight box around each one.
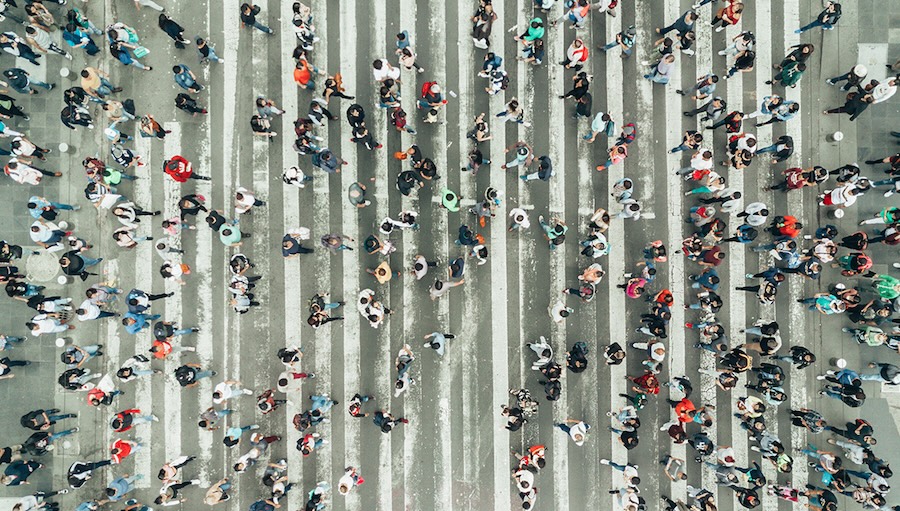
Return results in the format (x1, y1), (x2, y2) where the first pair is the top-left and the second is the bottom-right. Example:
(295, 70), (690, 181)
(0, 0), (900, 511)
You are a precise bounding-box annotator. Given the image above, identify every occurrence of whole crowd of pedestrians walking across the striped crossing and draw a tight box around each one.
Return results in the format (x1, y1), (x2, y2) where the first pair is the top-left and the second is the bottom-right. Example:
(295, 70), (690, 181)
(0, 0), (900, 511)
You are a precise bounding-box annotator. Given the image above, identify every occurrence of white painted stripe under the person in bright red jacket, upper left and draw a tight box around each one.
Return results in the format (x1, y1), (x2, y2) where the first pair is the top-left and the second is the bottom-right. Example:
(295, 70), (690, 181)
(163, 122), (184, 460)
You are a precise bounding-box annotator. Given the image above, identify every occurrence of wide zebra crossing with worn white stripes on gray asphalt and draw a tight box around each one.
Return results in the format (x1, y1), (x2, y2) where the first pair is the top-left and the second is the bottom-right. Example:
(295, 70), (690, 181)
(8, 0), (880, 510)
